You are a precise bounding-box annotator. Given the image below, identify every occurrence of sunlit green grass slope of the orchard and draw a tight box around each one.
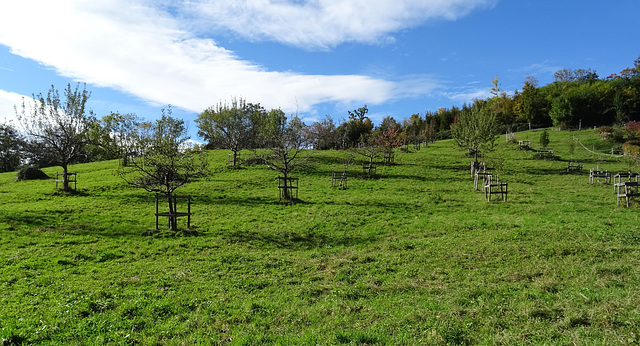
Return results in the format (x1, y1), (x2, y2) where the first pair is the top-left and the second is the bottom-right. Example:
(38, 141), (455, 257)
(0, 130), (640, 345)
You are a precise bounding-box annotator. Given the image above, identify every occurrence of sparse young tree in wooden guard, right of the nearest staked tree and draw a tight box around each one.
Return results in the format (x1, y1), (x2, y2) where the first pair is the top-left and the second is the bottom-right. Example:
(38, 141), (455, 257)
(253, 109), (313, 202)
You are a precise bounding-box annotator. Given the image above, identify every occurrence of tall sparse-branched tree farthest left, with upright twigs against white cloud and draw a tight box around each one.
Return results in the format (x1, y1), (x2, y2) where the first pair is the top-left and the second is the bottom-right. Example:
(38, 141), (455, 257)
(16, 84), (93, 191)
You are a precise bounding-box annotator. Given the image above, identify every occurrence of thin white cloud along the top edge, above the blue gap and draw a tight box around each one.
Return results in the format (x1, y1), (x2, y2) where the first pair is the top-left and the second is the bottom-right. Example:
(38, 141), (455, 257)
(185, 0), (497, 49)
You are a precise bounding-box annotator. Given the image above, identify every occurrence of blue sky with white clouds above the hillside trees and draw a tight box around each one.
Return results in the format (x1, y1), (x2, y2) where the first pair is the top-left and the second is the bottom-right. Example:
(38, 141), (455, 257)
(0, 0), (640, 139)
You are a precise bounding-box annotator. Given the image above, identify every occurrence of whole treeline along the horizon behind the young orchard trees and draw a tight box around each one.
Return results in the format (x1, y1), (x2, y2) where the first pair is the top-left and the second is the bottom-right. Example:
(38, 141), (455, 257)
(0, 57), (640, 172)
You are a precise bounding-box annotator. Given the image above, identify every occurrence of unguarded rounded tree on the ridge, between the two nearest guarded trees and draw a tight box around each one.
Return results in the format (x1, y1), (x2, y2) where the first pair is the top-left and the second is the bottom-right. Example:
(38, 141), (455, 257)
(196, 99), (265, 167)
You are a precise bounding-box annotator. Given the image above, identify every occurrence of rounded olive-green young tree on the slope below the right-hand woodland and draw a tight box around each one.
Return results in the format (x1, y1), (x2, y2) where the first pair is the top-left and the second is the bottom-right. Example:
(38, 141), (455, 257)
(451, 101), (498, 162)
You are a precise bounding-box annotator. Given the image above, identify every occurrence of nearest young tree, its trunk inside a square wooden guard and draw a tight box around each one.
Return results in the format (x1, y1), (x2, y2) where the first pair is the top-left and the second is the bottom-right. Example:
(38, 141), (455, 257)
(119, 108), (207, 231)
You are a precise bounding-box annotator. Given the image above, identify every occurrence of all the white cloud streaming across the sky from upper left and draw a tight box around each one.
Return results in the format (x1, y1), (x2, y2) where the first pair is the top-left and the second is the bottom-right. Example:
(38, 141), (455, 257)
(0, 0), (494, 116)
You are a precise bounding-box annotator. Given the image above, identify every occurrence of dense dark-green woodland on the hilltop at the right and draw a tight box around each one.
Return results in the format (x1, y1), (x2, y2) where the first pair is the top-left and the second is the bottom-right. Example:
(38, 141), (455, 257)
(425, 57), (640, 138)
